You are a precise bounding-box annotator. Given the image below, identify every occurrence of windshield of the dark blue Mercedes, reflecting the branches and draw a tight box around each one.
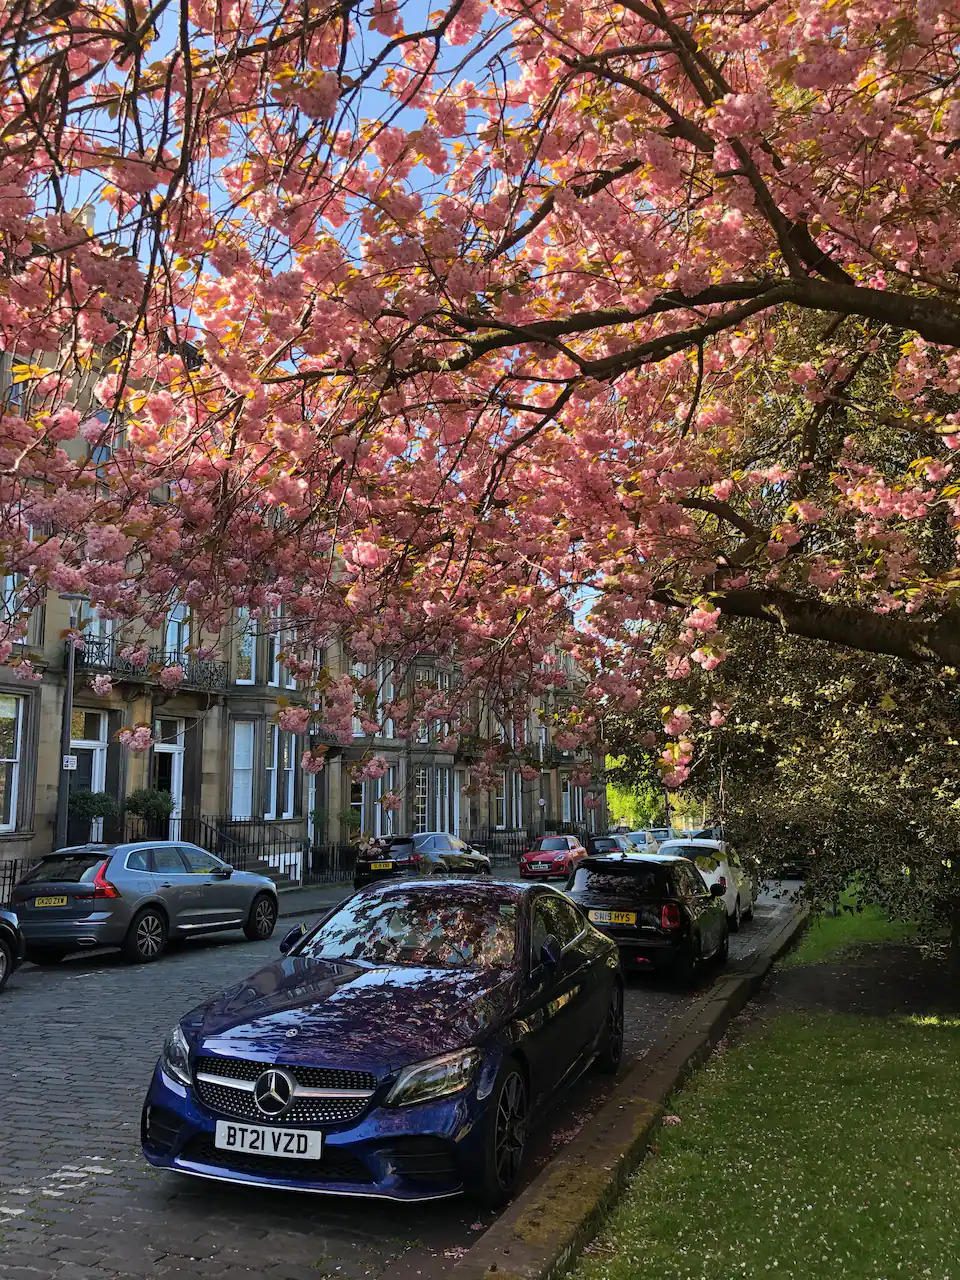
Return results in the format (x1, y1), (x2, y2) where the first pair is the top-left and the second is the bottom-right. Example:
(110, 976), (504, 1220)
(300, 887), (517, 969)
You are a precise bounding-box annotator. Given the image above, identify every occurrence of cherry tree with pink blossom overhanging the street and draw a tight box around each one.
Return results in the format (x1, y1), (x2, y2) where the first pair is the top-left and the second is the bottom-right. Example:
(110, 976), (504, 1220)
(0, 0), (960, 752)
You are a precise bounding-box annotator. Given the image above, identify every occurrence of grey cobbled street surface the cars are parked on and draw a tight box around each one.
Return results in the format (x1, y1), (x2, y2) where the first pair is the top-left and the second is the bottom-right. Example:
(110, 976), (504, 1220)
(0, 886), (794, 1280)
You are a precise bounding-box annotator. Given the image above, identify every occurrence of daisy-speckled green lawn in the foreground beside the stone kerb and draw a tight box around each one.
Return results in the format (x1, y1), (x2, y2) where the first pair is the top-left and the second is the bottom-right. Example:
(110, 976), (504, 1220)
(572, 1014), (960, 1280)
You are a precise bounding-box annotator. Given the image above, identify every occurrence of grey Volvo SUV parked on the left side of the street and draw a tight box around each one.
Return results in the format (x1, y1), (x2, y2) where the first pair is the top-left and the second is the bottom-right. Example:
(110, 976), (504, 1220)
(13, 840), (278, 964)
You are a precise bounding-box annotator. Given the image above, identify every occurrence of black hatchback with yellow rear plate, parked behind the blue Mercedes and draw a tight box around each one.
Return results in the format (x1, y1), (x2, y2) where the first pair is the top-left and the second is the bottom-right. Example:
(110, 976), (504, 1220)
(567, 854), (730, 982)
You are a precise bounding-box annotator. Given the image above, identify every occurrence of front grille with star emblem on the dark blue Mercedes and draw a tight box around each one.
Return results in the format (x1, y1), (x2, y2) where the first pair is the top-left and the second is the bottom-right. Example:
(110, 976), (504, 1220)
(196, 1057), (378, 1125)
